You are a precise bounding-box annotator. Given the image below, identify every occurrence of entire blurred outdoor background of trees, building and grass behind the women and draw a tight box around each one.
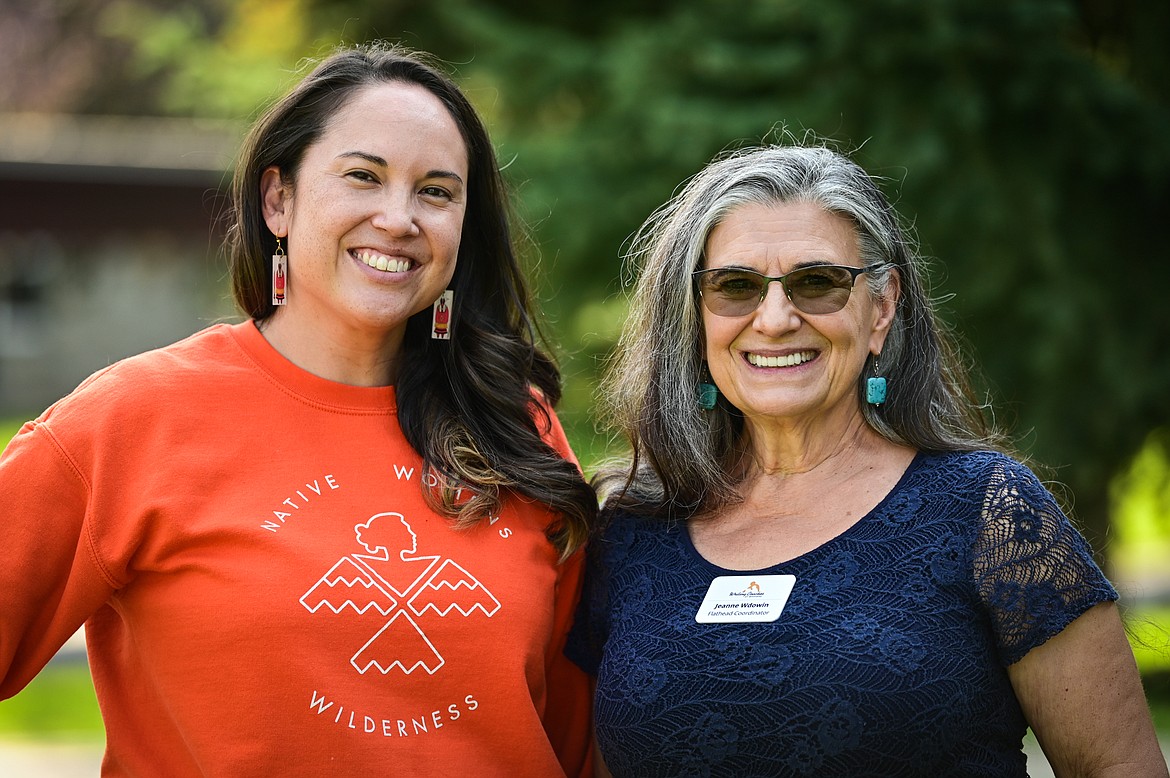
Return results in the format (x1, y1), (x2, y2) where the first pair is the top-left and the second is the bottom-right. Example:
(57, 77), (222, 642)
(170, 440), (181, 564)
(0, 0), (1170, 774)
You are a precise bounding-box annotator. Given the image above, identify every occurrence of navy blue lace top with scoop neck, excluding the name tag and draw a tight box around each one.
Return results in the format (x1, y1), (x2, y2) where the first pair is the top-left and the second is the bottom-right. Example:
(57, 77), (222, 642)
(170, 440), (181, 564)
(566, 452), (1117, 778)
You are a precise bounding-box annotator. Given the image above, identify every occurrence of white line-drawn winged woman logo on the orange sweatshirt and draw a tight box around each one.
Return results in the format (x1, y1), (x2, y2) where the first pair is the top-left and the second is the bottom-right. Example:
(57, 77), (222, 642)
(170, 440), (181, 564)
(301, 512), (500, 675)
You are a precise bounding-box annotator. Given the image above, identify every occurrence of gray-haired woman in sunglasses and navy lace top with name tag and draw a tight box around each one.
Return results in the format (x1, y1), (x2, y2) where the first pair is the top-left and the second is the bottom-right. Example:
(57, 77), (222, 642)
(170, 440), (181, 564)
(567, 146), (1166, 778)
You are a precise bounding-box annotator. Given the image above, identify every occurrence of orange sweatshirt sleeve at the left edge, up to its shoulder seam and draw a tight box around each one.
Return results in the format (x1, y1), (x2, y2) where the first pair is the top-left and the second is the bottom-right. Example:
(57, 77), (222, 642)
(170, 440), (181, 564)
(0, 421), (113, 700)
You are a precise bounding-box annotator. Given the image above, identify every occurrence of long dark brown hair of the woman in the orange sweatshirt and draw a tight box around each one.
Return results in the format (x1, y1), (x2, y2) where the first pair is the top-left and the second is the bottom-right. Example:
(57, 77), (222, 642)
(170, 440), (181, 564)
(227, 43), (597, 557)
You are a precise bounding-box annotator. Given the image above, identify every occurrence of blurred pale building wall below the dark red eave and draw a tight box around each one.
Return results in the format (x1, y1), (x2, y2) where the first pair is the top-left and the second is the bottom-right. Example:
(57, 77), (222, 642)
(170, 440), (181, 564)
(0, 229), (238, 419)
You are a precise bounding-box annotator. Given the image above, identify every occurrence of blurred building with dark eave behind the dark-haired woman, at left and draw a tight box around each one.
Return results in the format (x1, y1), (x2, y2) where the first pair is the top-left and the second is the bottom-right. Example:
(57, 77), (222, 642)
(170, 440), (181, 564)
(0, 113), (242, 416)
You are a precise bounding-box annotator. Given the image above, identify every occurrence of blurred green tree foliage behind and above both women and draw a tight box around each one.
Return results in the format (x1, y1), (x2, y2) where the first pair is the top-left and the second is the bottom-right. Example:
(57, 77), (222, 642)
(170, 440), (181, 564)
(13, 0), (1170, 559)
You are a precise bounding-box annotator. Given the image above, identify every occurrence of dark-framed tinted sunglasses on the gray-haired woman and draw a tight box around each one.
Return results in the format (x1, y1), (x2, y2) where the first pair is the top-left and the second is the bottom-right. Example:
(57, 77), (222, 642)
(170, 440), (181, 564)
(691, 262), (888, 316)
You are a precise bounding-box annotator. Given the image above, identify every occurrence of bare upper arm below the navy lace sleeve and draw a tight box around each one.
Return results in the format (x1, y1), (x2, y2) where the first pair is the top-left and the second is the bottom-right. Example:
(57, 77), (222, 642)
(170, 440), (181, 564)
(1007, 603), (1168, 778)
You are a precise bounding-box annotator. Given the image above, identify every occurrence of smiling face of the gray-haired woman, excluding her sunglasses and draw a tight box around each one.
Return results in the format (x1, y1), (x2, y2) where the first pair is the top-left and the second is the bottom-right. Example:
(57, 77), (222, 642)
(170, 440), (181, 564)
(702, 202), (894, 424)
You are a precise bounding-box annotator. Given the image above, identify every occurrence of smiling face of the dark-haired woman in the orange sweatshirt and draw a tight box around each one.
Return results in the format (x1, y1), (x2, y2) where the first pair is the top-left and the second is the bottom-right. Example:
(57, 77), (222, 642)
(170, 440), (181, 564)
(261, 82), (468, 356)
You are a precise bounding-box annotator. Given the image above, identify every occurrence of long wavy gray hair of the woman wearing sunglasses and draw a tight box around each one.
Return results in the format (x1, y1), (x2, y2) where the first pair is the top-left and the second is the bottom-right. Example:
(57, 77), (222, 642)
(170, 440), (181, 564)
(596, 145), (1003, 519)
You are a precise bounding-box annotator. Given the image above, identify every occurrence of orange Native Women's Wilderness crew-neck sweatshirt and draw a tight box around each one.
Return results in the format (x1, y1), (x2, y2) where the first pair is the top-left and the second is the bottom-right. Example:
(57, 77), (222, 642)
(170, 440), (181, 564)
(0, 322), (589, 778)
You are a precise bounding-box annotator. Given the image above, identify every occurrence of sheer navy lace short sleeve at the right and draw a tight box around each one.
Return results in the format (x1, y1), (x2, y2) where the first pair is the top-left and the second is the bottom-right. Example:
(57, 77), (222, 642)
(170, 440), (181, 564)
(973, 459), (1117, 666)
